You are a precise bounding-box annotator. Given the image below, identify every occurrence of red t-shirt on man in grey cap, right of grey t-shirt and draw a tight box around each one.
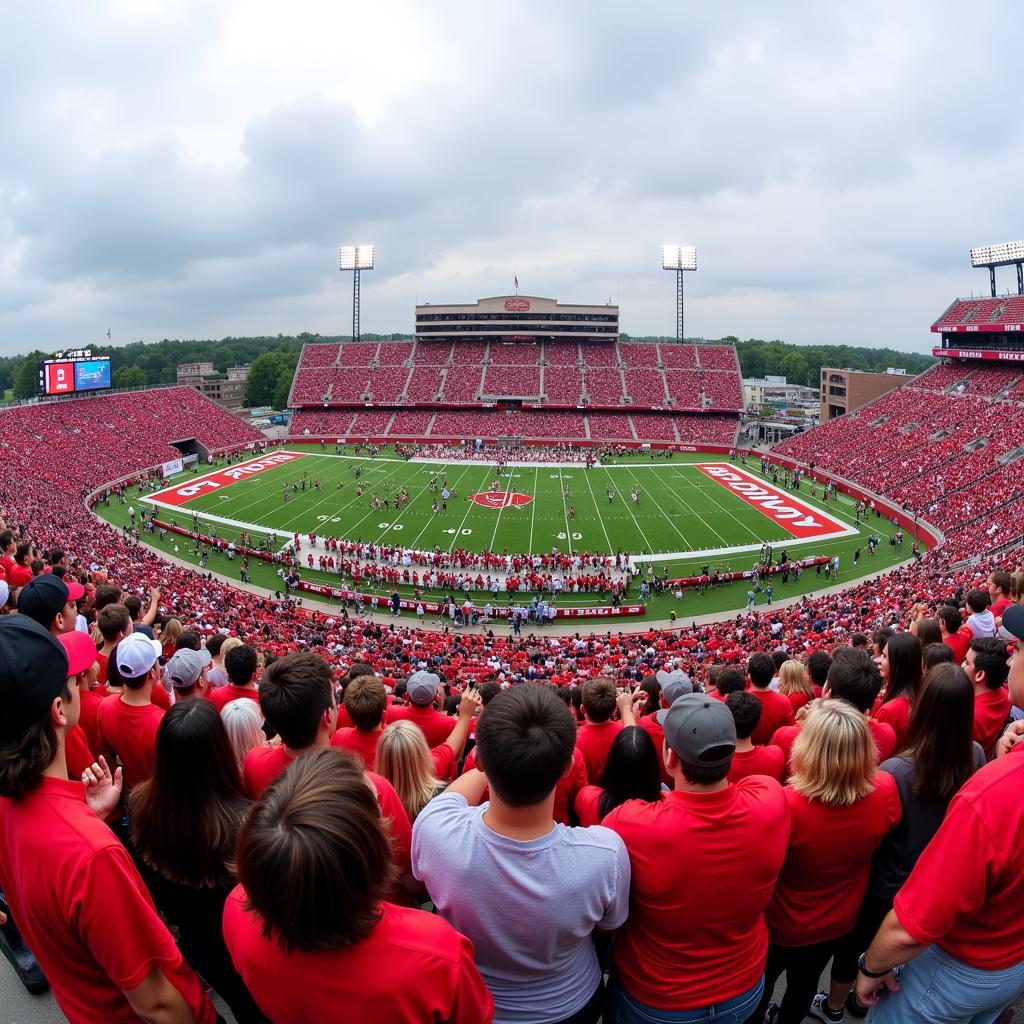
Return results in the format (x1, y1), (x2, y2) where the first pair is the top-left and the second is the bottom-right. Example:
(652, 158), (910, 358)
(602, 774), (790, 1011)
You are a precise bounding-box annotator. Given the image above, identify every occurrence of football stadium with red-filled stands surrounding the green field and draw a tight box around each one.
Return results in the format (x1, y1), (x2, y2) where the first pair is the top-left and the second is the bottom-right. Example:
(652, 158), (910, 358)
(0, 253), (1024, 1021)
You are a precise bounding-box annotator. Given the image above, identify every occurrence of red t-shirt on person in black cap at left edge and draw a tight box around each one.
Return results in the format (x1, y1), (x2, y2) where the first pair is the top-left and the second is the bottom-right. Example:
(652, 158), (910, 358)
(0, 774), (216, 1024)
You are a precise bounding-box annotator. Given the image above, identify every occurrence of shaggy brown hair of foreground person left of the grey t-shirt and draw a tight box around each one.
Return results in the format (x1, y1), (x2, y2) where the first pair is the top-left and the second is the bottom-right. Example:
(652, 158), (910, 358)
(238, 749), (394, 953)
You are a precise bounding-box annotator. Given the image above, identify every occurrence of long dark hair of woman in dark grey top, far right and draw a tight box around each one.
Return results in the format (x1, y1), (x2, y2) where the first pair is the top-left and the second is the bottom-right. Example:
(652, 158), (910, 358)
(905, 659), (975, 802)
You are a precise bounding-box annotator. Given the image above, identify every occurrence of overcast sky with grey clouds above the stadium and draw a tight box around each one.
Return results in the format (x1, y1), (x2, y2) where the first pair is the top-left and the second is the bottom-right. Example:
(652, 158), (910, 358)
(0, 0), (1024, 354)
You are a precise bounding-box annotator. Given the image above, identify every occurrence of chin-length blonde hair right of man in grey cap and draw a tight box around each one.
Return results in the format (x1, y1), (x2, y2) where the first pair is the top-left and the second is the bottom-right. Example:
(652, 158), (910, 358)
(790, 700), (879, 807)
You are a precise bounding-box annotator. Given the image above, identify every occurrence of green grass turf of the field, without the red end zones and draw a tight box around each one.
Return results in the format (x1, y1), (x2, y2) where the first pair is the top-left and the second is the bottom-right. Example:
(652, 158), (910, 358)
(97, 444), (909, 623)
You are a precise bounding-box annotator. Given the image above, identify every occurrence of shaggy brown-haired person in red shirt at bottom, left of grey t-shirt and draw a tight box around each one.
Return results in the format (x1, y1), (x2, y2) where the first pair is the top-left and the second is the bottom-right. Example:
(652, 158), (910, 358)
(224, 750), (494, 1024)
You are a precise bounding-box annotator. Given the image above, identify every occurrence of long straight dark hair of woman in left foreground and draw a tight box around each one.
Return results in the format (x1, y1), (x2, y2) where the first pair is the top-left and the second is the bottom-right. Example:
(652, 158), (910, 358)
(128, 699), (249, 889)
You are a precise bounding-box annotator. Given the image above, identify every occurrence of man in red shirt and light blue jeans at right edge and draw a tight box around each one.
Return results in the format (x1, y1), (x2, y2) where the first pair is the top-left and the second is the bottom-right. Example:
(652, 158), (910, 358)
(857, 604), (1024, 1024)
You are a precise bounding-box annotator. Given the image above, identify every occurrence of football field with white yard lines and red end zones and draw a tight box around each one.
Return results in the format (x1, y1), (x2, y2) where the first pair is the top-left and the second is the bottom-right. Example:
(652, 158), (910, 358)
(99, 444), (909, 617)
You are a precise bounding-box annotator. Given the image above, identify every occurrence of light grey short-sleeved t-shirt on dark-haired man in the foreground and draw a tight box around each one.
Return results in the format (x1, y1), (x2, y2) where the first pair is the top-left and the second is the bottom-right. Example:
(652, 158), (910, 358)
(413, 793), (630, 1024)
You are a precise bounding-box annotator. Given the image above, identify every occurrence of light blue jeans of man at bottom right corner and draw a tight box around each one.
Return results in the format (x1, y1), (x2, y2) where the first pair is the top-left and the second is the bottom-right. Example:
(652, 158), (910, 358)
(867, 946), (1024, 1024)
